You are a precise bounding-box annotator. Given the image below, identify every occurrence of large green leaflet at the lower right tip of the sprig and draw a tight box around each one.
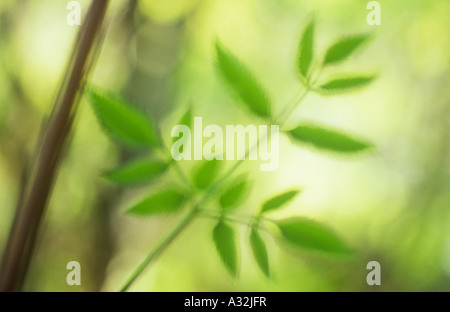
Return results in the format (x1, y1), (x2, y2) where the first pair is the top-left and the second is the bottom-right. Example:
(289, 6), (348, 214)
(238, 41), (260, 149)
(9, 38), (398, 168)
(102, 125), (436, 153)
(277, 218), (352, 256)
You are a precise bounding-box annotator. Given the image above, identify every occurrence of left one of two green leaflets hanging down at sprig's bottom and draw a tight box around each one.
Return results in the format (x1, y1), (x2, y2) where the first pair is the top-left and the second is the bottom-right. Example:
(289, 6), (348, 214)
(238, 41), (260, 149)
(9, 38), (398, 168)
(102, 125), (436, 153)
(213, 221), (237, 277)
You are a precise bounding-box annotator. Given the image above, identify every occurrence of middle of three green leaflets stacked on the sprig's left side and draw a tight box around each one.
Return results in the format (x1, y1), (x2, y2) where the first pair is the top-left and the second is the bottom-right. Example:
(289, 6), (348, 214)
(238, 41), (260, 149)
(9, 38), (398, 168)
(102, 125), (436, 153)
(104, 159), (169, 185)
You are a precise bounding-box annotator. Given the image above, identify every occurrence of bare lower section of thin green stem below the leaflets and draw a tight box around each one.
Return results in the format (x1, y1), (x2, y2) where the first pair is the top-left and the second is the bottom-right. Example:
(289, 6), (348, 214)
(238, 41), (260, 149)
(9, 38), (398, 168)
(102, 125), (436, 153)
(120, 209), (198, 292)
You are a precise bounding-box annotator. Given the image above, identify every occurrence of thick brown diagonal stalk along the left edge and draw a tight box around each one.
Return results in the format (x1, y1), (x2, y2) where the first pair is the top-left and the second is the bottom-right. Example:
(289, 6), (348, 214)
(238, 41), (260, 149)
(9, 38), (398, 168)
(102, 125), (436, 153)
(0, 0), (108, 291)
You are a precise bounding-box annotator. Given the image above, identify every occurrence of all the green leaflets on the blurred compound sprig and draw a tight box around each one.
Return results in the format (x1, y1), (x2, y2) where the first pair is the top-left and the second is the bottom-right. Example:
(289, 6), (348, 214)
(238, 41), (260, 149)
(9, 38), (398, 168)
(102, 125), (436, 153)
(87, 21), (375, 276)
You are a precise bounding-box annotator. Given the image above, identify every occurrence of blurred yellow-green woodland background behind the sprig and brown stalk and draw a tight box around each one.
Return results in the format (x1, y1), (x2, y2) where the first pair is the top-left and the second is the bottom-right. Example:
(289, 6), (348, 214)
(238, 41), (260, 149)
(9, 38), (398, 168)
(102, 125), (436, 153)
(0, 0), (450, 291)
